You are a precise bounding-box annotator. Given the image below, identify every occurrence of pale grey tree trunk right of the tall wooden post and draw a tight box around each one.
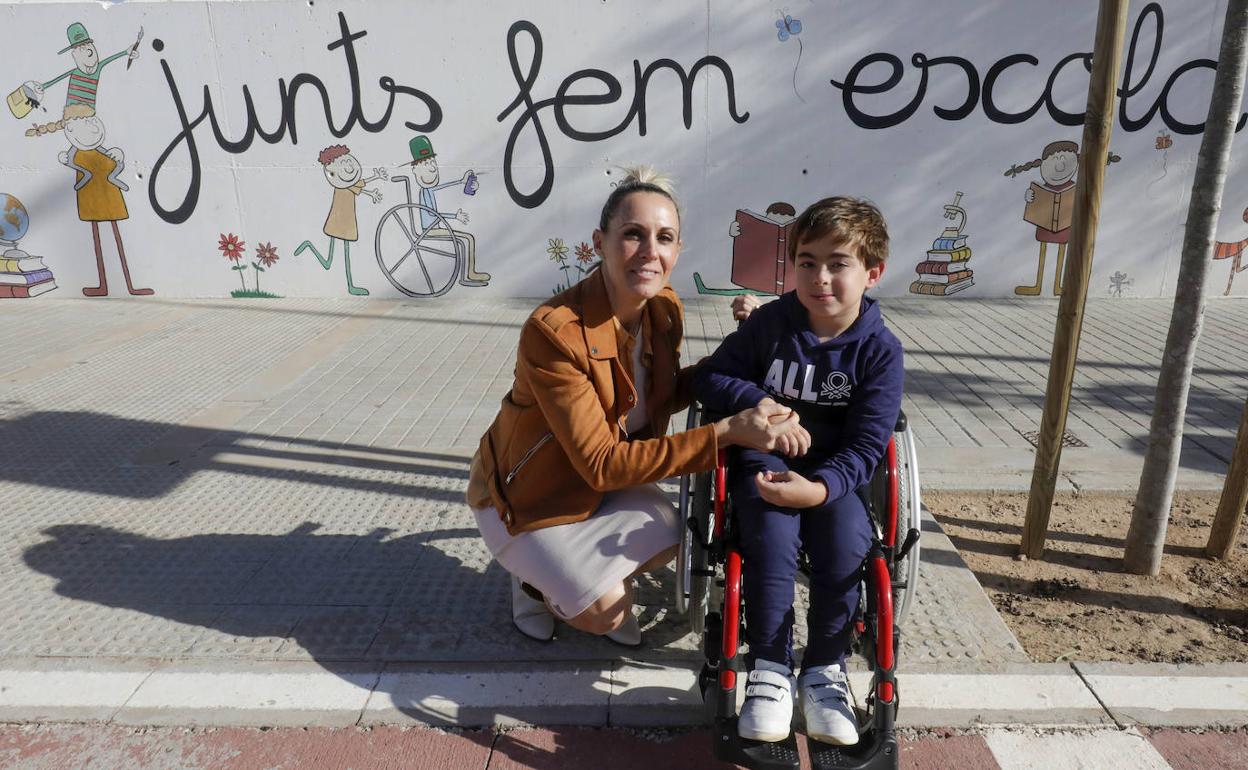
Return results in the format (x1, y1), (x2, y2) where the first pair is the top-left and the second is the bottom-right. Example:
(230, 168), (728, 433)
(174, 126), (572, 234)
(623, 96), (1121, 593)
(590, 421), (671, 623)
(1123, 0), (1248, 575)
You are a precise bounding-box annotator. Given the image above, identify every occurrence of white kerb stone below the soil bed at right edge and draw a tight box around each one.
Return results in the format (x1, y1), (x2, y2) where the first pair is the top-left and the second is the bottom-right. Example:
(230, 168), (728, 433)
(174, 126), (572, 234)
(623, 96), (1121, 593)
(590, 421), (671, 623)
(1087, 674), (1248, 711)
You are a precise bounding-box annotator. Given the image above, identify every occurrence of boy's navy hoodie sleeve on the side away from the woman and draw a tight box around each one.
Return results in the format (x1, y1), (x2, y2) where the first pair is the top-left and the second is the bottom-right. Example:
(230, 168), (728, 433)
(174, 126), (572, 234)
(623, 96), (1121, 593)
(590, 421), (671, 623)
(811, 339), (905, 505)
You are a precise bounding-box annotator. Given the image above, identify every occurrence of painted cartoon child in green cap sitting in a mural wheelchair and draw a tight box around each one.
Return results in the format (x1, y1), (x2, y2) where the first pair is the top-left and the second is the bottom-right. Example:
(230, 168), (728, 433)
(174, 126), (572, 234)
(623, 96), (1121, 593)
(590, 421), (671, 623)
(376, 136), (490, 297)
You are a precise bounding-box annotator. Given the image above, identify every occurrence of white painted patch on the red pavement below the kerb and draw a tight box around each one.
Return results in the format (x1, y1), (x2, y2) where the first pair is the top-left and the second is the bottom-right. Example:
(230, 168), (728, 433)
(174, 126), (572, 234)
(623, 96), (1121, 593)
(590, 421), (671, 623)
(983, 730), (1171, 770)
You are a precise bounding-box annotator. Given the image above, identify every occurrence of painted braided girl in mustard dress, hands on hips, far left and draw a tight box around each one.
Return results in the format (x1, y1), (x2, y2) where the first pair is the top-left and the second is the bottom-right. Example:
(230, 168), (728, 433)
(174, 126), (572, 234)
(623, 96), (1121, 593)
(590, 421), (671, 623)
(54, 104), (154, 297)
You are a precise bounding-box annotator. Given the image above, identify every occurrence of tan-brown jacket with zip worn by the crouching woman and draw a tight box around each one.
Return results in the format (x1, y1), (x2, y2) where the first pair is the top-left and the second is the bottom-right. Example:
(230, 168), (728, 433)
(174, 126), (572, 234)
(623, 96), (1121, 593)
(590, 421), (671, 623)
(468, 270), (716, 534)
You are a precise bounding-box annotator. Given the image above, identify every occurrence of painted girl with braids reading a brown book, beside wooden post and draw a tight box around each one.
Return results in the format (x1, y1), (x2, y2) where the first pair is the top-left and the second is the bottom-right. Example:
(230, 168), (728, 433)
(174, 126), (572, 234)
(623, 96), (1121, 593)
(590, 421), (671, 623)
(1006, 141), (1080, 297)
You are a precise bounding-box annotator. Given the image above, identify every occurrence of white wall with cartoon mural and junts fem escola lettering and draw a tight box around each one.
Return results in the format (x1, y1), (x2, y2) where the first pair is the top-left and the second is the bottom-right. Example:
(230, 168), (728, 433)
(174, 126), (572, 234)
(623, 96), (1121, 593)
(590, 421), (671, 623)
(0, 0), (1248, 302)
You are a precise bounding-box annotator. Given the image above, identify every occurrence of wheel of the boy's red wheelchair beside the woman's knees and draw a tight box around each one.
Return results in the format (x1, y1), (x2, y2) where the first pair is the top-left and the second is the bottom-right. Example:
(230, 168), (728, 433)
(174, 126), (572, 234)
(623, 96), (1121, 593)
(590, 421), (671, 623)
(676, 404), (713, 636)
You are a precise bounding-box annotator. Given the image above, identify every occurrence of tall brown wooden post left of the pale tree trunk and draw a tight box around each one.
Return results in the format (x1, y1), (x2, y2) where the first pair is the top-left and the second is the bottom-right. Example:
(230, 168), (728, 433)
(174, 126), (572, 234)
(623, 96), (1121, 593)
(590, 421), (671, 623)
(1021, 0), (1127, 559)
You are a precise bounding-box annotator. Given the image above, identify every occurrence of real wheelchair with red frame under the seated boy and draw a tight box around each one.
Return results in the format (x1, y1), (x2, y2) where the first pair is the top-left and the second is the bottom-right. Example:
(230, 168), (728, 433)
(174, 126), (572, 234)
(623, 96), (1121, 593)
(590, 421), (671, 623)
(675, 404), (922, 770)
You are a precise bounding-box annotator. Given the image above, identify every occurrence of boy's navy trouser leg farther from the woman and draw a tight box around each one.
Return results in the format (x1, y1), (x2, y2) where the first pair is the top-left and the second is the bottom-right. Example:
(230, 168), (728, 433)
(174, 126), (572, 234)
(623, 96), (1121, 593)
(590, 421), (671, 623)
(801, 492), (871, 669)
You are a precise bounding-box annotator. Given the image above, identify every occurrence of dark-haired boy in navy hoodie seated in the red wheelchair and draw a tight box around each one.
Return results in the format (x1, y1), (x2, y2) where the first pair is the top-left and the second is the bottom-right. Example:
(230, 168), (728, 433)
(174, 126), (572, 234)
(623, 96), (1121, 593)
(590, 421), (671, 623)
(694, 197), (902, 745)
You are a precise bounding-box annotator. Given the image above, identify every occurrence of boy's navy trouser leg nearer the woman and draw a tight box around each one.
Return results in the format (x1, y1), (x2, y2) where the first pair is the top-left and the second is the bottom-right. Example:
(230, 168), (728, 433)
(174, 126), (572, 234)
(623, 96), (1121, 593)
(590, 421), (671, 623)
(730, 449), (801, 668)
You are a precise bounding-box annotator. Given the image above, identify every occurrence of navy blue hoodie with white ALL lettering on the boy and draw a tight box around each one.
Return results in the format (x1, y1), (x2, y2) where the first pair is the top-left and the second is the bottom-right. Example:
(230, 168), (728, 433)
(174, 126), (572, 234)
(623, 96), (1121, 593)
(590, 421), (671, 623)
(694, 292), (904, 502)
